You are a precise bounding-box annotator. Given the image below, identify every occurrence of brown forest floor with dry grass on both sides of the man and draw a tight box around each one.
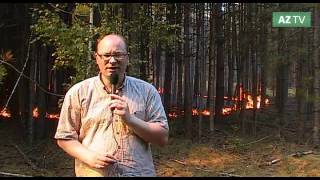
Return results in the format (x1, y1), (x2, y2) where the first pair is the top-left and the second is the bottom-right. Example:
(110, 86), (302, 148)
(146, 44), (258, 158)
(0, 106), (320, 177)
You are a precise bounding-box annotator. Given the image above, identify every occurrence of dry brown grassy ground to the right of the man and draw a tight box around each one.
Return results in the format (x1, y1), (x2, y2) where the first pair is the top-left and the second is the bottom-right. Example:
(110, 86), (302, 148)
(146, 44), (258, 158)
(153, 134), (320, 177)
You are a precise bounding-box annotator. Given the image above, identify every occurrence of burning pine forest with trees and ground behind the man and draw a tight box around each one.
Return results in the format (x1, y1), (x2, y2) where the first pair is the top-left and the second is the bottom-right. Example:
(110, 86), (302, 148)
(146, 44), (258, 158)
(0, 3), (320, 177)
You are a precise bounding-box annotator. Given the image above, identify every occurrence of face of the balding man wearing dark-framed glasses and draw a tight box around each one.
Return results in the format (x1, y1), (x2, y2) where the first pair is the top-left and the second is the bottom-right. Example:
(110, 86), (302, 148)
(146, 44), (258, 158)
(95, 35), (129, 79)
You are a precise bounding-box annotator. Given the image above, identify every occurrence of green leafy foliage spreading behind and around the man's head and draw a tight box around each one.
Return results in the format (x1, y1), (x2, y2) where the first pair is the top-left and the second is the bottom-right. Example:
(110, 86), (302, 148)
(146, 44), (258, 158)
(31, 3), (178, 85)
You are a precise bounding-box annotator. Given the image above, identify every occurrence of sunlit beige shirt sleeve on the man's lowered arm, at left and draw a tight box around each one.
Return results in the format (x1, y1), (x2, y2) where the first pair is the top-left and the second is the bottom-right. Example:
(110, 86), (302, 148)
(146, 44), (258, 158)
(54, 88), (81, 140)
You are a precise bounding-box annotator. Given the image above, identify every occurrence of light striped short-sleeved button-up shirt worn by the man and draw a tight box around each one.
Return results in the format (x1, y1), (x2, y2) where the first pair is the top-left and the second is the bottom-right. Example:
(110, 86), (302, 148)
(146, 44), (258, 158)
(55, 76), (169, 176)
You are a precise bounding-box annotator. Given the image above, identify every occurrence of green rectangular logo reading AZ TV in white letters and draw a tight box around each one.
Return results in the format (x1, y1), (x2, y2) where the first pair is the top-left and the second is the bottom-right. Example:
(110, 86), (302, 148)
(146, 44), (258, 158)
(272, 12), (311, 27)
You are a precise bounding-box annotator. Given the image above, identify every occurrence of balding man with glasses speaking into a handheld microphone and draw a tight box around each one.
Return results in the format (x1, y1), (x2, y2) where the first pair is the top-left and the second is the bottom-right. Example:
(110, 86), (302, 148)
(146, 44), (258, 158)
(55, 34), (169, 176)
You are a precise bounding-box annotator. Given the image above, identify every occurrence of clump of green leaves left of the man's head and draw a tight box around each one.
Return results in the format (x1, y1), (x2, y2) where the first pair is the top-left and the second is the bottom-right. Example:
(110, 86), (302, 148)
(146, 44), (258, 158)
(31, 5), (93, 84)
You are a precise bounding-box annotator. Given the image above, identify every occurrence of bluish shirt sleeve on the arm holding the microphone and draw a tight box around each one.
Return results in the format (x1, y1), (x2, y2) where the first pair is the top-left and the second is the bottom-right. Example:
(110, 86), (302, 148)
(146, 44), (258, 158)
(147, 86), (169, 130)
